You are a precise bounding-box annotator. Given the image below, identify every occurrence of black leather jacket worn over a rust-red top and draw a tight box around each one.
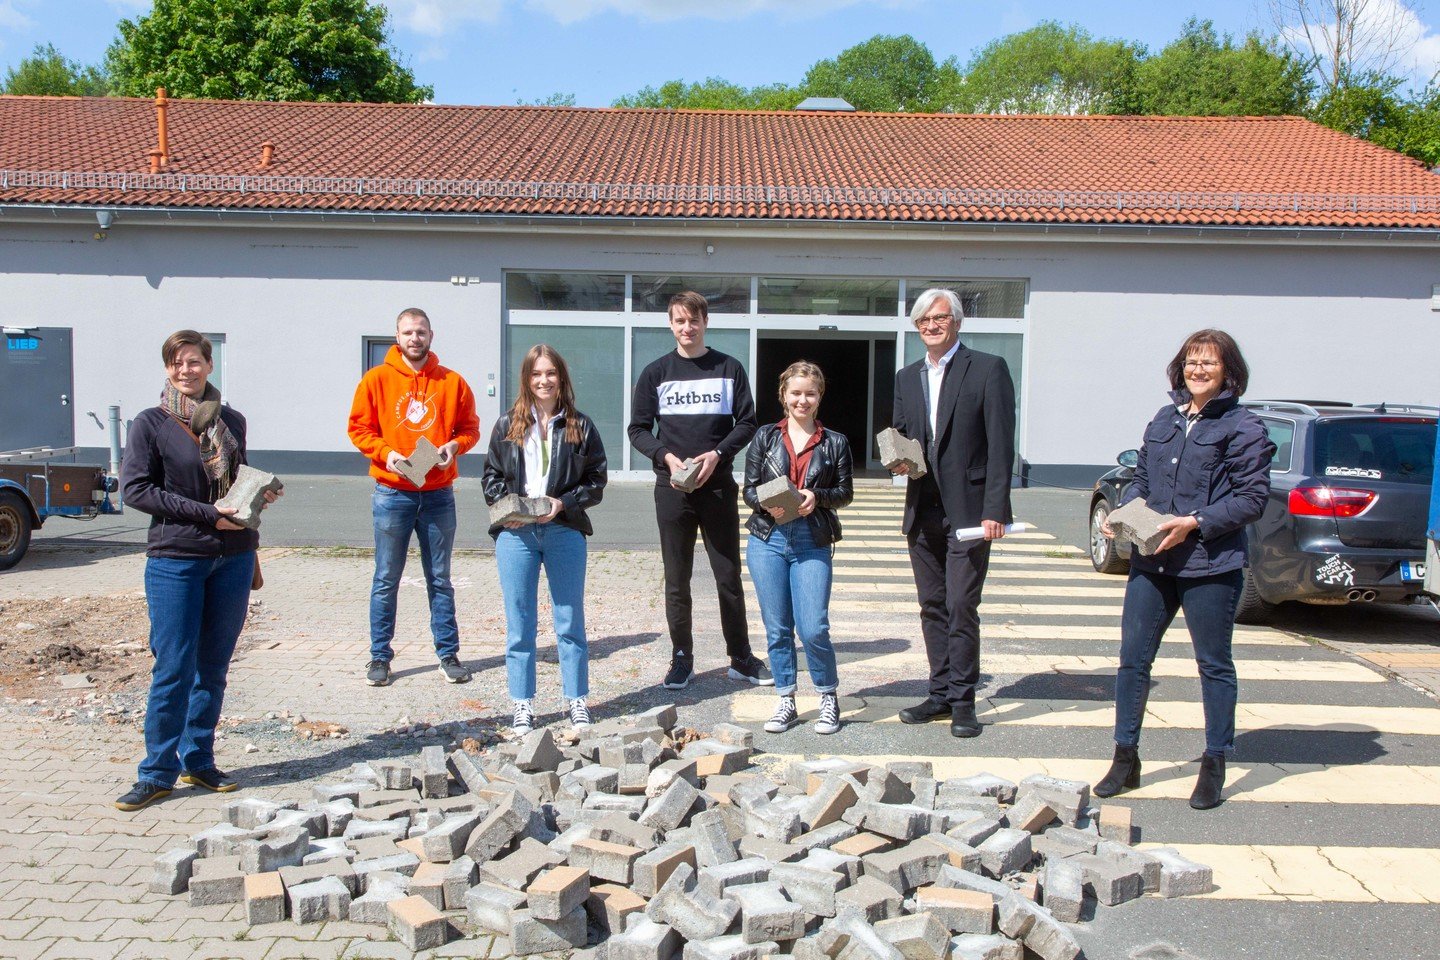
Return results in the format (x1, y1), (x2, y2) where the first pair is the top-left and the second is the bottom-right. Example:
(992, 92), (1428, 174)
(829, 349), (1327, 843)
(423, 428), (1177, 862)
(744, 423), (855, 547)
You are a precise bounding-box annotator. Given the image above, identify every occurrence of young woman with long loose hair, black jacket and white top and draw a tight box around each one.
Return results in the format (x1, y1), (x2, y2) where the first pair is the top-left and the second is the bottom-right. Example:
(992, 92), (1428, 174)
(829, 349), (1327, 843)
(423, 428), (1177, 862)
(484, 344), (606, 734)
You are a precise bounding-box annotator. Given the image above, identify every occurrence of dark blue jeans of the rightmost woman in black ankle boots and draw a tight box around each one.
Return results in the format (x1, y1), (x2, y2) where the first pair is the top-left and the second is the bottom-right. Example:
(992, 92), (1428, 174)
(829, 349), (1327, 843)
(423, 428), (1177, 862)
(1115, 569), (1244, 757)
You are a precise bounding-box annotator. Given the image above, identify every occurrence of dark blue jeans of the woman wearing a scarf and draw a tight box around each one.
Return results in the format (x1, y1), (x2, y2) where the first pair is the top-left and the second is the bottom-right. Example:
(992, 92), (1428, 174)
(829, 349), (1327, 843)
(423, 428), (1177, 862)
(138, 550), (255, 787)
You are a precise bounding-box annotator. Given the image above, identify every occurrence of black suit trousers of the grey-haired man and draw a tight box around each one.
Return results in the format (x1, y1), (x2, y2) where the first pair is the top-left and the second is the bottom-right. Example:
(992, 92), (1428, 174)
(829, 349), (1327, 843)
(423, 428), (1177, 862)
(909, 478), (991, 707)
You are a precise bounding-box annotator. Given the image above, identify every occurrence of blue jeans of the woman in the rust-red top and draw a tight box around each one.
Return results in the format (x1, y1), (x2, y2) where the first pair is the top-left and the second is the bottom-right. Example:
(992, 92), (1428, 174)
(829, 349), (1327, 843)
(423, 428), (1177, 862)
(744, 518), (840, 695)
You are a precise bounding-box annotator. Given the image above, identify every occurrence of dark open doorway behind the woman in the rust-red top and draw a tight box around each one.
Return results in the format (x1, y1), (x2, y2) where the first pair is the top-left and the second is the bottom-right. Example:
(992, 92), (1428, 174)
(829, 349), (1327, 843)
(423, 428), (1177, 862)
(755, 334), (869, 471)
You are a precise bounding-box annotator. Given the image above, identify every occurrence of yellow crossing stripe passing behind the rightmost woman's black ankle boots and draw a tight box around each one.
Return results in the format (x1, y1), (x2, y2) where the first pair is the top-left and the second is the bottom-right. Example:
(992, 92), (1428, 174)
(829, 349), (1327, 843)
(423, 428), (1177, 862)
(757, 754), (1440, 805)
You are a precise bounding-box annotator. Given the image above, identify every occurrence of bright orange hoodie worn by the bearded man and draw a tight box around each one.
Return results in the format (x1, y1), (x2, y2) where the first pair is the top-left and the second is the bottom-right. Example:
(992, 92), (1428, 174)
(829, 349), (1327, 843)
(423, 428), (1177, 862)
(350, 347), (480, 489)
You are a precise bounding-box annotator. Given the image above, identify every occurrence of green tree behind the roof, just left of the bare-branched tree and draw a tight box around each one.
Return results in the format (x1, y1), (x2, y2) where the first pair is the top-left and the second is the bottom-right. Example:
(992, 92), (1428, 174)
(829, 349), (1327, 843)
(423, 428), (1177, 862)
(1136, 17), (1310, 117)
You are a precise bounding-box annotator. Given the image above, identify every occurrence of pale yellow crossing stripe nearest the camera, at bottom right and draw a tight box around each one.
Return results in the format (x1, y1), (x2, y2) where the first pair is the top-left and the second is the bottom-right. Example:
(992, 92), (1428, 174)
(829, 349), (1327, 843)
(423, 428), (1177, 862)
(1139, 843), (1440, 903)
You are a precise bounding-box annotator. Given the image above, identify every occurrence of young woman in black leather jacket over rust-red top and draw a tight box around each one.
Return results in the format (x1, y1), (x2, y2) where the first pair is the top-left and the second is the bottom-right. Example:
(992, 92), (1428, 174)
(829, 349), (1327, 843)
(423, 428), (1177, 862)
(744, 360), (855, 734)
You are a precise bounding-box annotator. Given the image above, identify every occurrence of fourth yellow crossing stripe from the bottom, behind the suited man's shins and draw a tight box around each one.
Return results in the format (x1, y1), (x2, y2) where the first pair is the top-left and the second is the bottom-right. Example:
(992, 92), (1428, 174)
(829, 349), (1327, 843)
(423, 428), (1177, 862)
(845, 651), (1385, 684)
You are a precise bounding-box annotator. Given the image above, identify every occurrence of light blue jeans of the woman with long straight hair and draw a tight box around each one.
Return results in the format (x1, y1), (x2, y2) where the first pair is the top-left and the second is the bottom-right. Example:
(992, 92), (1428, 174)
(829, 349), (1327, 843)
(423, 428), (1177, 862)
(495, 521), (590, 699)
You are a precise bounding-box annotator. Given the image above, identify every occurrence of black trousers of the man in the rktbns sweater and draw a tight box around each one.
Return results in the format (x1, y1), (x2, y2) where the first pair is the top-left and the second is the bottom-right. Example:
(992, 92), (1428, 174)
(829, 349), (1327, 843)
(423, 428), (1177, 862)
(655, 475), (750, 661)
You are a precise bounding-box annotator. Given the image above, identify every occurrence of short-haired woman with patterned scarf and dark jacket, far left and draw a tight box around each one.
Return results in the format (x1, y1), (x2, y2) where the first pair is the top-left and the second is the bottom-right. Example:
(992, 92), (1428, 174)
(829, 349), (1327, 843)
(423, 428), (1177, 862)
(115, 330), (275, 810)
